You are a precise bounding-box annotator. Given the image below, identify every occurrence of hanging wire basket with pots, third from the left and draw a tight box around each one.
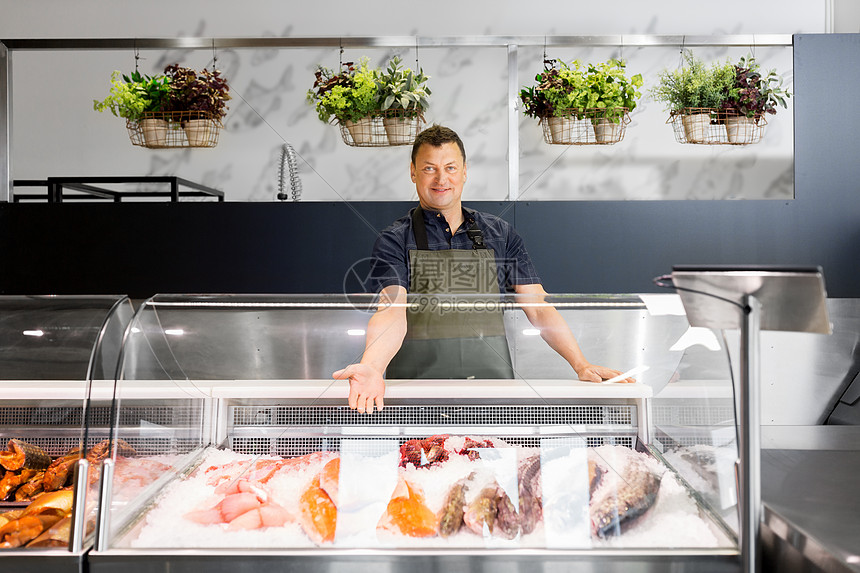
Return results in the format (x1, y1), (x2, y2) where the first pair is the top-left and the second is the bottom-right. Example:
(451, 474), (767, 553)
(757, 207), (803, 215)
(541, 107), (630, 145)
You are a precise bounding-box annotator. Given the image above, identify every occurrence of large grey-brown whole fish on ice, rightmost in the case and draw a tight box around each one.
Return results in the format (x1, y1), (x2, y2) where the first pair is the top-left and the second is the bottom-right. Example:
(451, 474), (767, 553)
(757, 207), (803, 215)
(590, 460), (661, 537)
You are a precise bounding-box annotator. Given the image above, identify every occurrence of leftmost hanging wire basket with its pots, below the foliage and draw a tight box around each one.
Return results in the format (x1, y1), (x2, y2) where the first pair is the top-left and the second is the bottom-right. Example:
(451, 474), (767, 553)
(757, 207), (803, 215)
(126, 111), (223, 149)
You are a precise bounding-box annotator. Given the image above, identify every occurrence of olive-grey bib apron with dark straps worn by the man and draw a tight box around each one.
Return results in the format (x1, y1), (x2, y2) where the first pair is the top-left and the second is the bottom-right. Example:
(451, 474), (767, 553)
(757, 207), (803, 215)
(386, 207), (514, 379)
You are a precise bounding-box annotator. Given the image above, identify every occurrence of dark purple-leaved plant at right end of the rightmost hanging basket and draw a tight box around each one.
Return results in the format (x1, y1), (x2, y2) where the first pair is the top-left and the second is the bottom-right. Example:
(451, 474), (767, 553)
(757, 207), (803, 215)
(722, 56), (791, 119)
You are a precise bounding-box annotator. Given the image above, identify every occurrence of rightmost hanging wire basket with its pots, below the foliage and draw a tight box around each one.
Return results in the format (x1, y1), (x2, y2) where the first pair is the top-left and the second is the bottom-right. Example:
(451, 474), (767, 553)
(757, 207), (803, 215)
(666, 107), (767, 145)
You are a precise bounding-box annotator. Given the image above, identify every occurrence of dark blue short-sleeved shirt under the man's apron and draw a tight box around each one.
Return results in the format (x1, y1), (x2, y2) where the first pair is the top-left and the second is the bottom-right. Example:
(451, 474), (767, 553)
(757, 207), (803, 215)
(365, 208), (540, 293)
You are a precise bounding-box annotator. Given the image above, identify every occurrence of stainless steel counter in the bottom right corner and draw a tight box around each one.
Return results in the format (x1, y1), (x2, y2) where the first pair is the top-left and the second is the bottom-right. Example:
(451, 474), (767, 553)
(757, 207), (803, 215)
(762, 426), (860, 573)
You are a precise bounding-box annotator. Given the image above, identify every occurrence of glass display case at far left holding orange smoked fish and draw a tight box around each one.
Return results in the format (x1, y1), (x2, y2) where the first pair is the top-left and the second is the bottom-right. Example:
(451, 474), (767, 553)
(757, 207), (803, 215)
(0, 295), (134, 572)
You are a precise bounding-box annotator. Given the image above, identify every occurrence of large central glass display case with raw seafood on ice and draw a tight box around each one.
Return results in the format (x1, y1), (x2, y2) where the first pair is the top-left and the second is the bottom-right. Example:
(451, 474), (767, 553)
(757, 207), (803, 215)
(88, 295), (740, 572)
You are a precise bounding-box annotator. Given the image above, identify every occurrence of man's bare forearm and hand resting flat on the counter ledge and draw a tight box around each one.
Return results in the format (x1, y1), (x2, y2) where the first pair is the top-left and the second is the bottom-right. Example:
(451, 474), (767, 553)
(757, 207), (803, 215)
(514, 284), (634, 382)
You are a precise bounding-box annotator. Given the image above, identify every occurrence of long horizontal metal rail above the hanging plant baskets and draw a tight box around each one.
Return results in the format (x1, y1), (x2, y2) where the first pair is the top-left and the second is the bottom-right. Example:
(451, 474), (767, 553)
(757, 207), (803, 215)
(0, 34), (793, 50)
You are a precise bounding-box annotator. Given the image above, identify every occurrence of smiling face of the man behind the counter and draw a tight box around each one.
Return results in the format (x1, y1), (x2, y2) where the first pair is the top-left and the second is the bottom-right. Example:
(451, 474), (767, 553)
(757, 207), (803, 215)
(409, 143), (466, 211)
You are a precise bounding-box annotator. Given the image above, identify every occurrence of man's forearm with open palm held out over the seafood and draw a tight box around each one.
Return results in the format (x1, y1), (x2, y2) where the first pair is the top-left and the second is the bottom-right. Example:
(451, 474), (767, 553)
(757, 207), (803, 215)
(332, 285), (406, 413)
